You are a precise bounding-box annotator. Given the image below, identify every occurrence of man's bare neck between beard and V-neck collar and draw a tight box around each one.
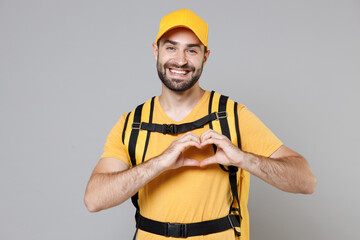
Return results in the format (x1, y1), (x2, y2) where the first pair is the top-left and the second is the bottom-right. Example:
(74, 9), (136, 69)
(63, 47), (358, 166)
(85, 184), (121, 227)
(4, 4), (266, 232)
(159, 83), (205, 121)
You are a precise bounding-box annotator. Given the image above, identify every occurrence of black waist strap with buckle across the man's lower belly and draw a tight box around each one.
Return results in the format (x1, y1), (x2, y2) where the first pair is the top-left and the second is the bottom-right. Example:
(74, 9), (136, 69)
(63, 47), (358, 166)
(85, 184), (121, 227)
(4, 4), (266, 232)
(136, 214), (240, 238)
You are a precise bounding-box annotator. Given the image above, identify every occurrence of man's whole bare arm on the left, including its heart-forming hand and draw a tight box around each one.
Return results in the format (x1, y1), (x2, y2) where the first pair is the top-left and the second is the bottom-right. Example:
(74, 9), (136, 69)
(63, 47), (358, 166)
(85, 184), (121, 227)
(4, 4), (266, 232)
(84, 133), (200, 212)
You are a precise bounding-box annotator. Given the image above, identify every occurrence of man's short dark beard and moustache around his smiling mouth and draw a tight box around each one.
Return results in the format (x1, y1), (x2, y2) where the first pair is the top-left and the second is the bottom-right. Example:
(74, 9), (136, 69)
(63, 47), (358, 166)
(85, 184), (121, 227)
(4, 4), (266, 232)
(156, 60), (204, 92)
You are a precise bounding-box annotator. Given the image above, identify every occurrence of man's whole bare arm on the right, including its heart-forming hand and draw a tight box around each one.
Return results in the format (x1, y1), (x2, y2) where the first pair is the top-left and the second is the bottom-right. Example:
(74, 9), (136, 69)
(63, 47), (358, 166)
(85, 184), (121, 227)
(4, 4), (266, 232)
(200, 130), (316, 194)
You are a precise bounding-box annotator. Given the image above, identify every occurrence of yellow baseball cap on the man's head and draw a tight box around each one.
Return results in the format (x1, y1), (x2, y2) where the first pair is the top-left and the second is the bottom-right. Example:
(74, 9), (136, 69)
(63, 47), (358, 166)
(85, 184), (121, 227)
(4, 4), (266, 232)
(155, 9), (209, 47)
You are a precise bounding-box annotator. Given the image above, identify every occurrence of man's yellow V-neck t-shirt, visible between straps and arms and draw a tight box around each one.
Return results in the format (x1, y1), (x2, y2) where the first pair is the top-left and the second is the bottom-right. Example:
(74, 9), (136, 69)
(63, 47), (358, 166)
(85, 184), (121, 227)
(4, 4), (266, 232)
(101, 91), (282, 240)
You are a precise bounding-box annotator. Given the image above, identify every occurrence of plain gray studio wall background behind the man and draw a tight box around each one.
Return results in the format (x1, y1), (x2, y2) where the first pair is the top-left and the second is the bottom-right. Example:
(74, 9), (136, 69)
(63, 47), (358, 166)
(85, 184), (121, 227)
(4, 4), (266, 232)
(0, 0), (360, 240)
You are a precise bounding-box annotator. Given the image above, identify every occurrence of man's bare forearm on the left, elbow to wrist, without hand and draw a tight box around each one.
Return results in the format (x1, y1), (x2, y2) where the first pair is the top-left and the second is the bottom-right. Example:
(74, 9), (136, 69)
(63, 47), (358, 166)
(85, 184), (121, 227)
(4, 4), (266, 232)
(85, 158), (163, 212)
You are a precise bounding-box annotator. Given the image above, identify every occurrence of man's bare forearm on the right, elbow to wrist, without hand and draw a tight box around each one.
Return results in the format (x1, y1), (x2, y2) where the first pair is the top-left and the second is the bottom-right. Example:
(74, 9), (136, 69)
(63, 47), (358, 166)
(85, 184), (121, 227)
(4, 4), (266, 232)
(239, 153), (316, 194)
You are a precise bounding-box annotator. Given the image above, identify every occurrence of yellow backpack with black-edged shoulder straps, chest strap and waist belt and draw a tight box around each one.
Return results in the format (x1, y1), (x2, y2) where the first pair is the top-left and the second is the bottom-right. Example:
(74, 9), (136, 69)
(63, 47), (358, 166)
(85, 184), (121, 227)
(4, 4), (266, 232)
(122, 91), (250, 239)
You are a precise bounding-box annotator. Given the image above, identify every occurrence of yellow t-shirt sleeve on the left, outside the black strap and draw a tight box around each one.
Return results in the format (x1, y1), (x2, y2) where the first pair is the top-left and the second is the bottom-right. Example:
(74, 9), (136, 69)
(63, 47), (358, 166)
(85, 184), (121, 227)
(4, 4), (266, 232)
(101, 114), (130, 166)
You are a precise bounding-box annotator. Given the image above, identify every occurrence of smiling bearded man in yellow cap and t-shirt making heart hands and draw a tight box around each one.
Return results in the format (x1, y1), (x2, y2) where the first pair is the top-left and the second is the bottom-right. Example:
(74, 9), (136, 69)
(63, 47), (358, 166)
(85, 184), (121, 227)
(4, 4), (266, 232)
(85, 9), (316, 239)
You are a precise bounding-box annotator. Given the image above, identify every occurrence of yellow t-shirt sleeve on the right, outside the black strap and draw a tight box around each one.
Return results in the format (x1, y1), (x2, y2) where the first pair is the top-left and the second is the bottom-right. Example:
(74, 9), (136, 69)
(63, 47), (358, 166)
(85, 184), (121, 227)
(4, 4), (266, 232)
(238, 104), (283, 157)
